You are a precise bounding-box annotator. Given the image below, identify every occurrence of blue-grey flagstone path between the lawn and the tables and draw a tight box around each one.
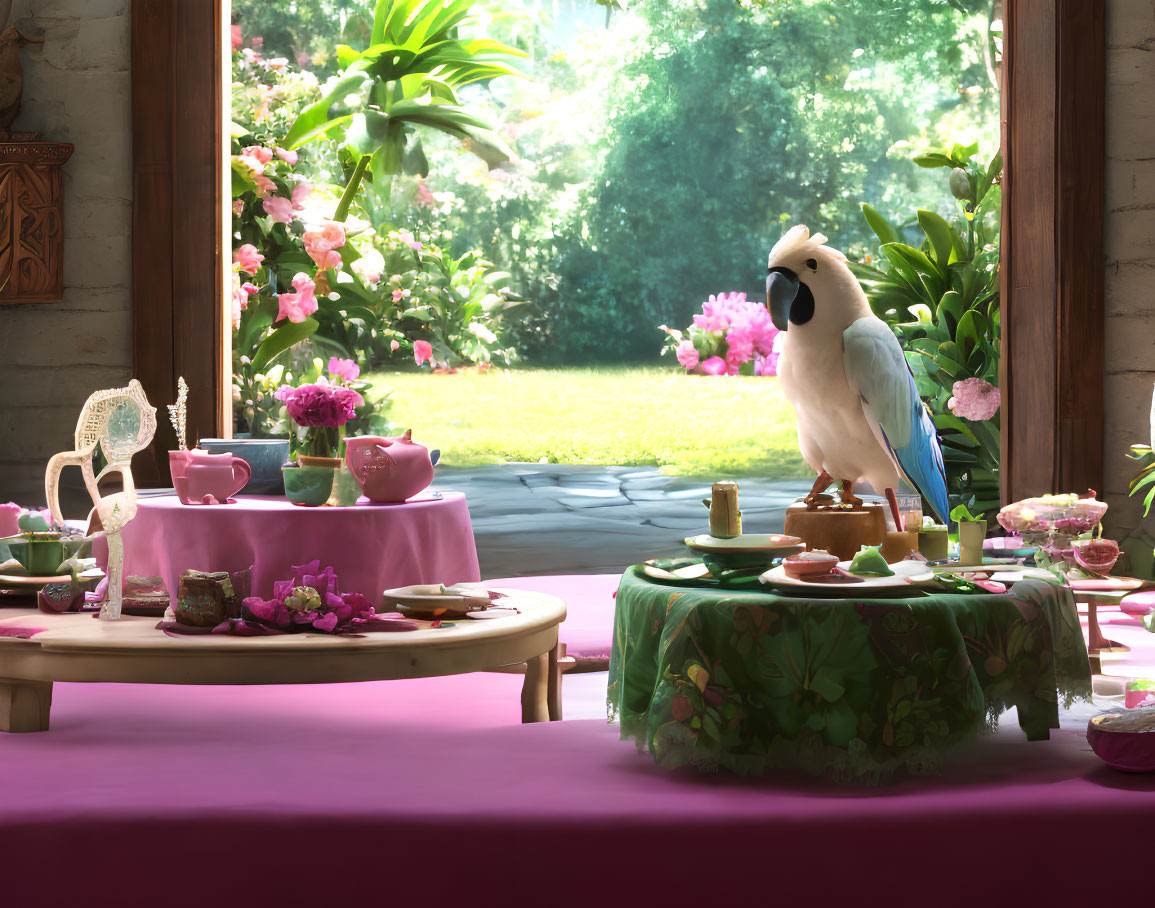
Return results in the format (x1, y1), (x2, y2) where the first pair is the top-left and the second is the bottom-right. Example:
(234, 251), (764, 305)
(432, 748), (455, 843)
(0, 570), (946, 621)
(433, 463), (811, 579)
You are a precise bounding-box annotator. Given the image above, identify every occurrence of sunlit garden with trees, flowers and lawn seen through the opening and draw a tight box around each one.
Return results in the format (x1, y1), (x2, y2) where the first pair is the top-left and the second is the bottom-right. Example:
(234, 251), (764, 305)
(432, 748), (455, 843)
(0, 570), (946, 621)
(232, 0), (1001, 509)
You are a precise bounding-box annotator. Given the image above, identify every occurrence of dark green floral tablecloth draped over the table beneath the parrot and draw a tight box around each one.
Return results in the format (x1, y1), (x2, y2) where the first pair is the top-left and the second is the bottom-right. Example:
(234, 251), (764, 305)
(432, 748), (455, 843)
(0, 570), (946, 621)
(609, 568), (1090, 782)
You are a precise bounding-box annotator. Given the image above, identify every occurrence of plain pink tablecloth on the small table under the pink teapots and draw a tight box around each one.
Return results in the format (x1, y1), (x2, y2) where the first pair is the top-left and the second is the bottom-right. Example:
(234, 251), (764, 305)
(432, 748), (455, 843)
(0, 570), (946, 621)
(97, 492), (480, 602)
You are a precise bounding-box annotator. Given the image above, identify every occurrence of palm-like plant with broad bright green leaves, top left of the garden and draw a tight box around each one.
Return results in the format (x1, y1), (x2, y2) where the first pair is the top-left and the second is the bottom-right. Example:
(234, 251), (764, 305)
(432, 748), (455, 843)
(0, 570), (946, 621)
(285, 0), (527, 221)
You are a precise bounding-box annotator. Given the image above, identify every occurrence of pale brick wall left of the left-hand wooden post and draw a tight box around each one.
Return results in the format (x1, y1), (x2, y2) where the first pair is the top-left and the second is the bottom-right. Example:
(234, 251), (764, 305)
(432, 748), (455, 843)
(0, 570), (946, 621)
(0, 0), (132, 505)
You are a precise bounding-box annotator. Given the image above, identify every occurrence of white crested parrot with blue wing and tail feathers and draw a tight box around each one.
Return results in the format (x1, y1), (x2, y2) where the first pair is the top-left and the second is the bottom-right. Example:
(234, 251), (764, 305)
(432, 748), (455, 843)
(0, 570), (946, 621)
(766, 226), (949, 529)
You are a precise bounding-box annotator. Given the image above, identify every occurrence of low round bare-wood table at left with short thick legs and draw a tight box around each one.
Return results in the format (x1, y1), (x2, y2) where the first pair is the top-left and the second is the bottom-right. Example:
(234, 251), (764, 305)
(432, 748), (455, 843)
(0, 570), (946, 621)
(0, 589), (566, 731)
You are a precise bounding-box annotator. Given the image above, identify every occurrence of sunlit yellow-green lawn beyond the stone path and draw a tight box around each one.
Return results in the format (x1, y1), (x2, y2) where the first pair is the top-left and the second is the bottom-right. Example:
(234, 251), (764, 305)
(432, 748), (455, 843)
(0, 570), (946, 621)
(370, 366), (810, 479)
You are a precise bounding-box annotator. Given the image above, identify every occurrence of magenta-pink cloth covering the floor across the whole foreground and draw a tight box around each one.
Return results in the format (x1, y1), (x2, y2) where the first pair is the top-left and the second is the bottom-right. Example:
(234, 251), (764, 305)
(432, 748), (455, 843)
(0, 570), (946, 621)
(0, 675), (1155, 908)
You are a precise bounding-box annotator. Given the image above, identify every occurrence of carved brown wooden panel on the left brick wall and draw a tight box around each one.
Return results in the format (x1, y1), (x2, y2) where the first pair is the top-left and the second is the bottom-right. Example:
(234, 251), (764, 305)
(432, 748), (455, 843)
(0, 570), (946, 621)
(0, 142), (73, 303)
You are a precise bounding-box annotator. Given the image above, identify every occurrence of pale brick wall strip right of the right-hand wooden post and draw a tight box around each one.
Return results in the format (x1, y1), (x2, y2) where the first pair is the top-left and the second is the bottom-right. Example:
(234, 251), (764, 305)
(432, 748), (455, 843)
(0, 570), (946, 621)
(1103, 0), (1155, 536)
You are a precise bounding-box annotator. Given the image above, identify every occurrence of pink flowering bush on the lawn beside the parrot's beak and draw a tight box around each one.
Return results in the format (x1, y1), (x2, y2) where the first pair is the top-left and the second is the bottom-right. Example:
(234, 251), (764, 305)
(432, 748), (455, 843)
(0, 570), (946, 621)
(662, 293), (781, 375)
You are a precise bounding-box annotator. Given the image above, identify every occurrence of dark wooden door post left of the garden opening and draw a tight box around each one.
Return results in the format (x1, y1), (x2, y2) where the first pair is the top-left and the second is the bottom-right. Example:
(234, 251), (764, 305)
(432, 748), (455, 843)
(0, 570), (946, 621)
(132, 0), (232, 486)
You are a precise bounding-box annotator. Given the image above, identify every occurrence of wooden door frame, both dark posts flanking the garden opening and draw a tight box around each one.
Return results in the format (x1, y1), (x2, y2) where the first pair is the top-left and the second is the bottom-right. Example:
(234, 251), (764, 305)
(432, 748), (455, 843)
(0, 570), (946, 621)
(132, 0), (1106, 500)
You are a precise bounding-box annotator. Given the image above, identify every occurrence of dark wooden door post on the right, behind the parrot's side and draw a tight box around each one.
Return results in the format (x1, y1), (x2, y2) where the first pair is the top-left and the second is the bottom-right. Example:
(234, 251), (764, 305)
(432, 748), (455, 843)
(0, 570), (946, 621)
(999, 0), (1106, 501)
